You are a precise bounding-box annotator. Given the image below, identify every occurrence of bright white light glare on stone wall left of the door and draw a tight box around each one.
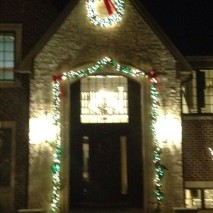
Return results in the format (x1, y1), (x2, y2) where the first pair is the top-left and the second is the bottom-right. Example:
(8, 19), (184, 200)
(29, 113), (56, 144)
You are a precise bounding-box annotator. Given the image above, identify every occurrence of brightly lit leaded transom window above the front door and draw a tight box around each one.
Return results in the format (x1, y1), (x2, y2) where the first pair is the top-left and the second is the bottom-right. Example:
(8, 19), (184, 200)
(80, 74), (129, 124)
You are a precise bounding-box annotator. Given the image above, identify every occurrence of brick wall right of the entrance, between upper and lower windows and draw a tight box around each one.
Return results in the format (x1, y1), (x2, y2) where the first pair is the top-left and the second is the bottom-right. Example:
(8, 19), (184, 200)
(183, 116), (213, 181)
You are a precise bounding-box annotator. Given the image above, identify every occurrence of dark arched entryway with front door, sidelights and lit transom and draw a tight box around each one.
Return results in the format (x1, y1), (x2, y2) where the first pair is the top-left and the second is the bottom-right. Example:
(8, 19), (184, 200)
(70, 74), (143, 208)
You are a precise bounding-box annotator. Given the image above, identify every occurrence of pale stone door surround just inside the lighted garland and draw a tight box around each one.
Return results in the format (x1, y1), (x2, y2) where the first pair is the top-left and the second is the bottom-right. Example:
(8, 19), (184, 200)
(60, 69), (154, 213)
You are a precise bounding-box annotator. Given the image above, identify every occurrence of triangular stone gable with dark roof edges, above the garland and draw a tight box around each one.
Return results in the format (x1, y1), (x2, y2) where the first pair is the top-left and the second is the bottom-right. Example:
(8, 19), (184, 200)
(18, 0), (190, 73)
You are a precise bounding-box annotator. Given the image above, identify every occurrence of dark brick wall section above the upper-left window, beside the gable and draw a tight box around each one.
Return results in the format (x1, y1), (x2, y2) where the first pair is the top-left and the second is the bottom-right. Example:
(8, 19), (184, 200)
(0, 0), (58, 57)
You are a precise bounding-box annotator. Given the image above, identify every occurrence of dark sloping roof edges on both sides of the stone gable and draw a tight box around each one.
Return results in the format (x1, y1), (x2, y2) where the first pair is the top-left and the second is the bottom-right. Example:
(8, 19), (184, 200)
(18, 0), (192, 72)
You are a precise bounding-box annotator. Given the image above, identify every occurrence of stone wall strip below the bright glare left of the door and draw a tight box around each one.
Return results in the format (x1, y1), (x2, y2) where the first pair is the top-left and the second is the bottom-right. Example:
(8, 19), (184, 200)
(28, 143), (53, 209)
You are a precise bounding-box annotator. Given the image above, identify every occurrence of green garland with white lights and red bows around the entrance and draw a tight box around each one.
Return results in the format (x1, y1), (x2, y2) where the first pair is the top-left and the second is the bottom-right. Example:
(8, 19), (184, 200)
(50, 57), (165, 213)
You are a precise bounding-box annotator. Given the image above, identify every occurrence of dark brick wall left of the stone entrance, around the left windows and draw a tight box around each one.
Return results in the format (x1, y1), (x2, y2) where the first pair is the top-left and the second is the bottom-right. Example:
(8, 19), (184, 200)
(0, 0), (58, 213)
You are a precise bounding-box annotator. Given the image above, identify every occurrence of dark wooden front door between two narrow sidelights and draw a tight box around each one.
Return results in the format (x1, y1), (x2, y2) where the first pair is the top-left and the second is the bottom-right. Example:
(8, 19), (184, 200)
(88, 131), (121, 202)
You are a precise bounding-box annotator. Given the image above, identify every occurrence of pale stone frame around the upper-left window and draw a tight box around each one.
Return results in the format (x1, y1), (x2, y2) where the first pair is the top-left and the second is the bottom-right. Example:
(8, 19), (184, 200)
(0, 24), (22, 82)
